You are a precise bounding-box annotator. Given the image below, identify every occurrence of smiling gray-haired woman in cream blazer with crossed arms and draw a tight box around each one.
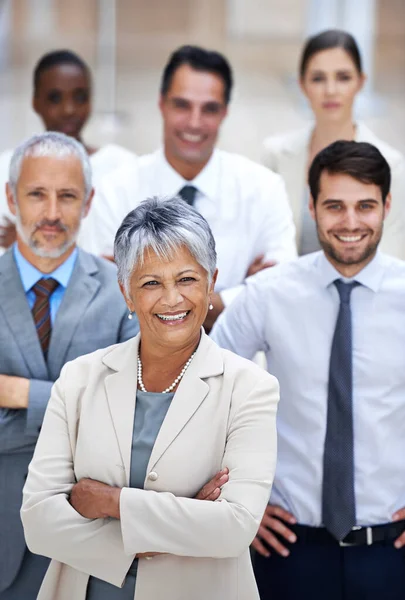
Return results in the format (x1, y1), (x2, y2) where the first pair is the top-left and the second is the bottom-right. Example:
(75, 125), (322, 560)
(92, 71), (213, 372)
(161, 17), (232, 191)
(21, 199), (279, 600)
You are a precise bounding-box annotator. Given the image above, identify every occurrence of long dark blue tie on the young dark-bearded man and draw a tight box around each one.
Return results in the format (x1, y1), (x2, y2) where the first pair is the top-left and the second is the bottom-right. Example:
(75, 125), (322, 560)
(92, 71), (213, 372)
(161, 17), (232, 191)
(322, 279), (359, 540)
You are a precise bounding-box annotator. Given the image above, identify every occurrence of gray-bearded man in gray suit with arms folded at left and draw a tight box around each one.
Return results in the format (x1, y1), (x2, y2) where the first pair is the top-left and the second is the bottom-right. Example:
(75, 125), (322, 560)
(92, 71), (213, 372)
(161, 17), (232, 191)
(0, 132), (138, 600)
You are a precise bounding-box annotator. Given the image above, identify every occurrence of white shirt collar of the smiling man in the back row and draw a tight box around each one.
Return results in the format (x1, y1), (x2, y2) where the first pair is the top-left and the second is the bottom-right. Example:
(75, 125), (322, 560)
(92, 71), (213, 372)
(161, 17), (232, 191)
(157, 148), (221, 200)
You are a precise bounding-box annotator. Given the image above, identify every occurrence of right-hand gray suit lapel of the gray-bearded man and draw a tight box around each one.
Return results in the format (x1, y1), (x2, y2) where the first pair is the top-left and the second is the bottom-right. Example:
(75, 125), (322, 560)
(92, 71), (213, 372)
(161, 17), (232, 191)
(48, 250), (100, 374)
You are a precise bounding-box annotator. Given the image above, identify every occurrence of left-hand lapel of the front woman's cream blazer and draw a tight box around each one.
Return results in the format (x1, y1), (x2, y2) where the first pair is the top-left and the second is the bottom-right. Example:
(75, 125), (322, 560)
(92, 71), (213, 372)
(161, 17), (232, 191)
(103, 334), (140, 485)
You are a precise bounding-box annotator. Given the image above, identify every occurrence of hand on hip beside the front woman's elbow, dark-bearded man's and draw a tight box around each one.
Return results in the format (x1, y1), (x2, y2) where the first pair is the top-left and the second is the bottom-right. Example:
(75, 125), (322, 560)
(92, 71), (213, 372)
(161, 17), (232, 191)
(252, 504), (297, 557)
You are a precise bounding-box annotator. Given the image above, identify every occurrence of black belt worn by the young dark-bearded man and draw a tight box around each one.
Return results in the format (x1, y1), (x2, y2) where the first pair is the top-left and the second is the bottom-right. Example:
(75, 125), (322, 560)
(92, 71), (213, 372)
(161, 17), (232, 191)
(288, 520), (405, 547)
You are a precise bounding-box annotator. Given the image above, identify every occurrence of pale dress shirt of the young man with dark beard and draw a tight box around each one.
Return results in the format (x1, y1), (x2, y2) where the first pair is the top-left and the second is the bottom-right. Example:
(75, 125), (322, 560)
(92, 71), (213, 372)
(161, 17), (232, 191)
(212, 252), (405, 526)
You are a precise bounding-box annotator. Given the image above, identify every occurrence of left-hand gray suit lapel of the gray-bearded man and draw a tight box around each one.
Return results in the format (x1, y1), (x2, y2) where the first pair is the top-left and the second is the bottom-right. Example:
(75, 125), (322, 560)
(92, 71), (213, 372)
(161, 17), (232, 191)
(0, 250), (48, 380)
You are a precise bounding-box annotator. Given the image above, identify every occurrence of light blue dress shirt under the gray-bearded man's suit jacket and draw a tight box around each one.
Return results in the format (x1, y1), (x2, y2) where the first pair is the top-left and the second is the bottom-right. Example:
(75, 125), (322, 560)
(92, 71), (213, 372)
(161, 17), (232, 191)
(13, 243), (77, 325)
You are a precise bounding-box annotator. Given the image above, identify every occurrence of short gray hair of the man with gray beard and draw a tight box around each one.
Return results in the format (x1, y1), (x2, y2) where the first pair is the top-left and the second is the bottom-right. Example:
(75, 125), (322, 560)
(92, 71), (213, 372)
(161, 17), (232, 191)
(9, 131), (92, 202)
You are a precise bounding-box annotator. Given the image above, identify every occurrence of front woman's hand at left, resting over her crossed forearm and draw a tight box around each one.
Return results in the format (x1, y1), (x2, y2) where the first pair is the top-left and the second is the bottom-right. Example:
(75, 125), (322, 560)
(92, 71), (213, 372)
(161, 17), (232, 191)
(69, 479), (121, 519)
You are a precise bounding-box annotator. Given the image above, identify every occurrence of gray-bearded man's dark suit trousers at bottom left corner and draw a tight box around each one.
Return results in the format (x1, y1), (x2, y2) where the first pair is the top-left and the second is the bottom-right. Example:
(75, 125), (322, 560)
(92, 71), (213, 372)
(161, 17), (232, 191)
(0, 550), (49, 600)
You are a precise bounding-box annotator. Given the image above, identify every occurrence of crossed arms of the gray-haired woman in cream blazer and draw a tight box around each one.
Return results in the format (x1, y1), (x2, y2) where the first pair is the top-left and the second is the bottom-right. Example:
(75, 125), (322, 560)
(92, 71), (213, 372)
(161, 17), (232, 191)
(21, 368), (278, 586)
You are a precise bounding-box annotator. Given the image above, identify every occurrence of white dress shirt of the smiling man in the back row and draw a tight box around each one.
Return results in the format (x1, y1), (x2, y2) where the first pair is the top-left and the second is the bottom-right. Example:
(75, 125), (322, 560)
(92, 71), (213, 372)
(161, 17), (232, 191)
(84, 150), (296, 304)
